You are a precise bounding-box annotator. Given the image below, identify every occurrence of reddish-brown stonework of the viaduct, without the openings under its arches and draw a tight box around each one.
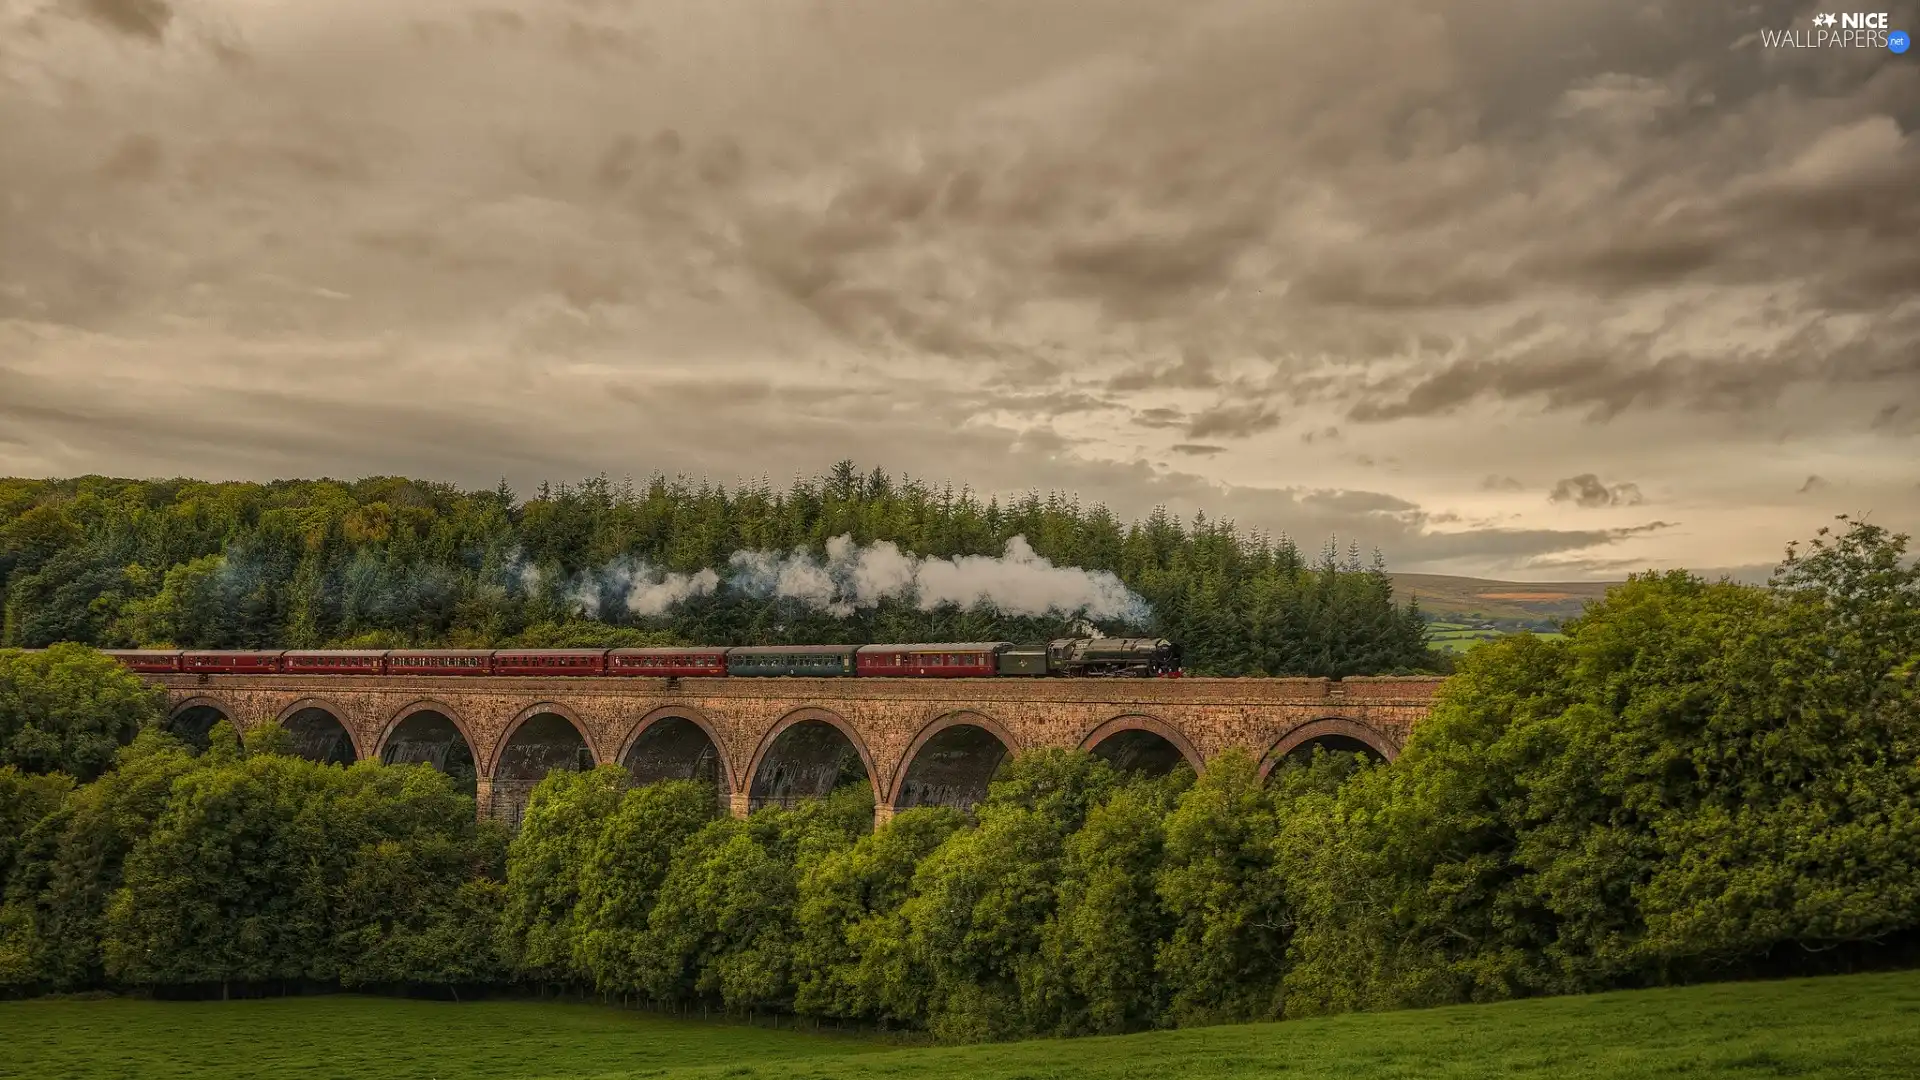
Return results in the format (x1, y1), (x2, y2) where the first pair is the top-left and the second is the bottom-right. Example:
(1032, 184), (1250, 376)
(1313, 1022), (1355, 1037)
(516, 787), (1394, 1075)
(144, 675), (1442, 821)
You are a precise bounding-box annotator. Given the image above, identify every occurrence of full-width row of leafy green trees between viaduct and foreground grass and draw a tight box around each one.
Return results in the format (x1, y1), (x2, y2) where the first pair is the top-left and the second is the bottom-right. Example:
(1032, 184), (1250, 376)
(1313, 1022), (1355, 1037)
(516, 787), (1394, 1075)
(0, 523), (1920, 1040)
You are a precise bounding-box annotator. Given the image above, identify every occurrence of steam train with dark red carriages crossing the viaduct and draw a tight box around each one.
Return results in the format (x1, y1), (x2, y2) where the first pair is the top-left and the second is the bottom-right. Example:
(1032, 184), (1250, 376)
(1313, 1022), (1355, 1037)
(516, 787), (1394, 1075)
(102, 638), (1181, 678)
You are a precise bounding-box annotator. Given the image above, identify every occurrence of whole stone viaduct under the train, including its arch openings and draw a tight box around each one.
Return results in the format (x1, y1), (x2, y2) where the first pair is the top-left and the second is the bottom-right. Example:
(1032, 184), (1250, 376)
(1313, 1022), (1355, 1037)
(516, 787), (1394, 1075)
(144, 675), (1442, 822)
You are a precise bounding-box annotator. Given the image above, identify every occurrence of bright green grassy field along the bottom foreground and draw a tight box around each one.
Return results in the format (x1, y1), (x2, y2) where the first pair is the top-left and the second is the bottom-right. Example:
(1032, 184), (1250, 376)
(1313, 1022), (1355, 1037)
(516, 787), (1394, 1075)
(0, 972), (1920, 1080)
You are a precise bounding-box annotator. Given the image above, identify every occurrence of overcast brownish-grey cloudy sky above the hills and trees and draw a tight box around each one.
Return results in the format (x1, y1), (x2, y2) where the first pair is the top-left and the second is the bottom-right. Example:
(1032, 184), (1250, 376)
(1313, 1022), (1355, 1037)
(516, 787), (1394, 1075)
(0, 0), (1920, 580)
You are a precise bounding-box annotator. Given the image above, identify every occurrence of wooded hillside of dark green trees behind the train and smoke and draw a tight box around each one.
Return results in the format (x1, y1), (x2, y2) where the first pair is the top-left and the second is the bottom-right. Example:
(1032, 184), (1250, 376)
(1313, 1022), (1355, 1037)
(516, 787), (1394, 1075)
(0, 461), (1448, 676)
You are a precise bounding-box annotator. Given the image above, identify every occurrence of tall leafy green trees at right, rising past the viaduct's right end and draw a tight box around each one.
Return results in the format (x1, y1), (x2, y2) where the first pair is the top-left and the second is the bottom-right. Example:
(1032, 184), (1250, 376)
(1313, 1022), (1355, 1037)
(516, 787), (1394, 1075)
(1281, 523), (1920, 1011)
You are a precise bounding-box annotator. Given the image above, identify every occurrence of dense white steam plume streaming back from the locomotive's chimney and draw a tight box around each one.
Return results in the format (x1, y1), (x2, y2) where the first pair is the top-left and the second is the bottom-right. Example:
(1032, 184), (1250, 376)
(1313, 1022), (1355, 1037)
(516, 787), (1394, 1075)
(728, 536), (1150, 625)
